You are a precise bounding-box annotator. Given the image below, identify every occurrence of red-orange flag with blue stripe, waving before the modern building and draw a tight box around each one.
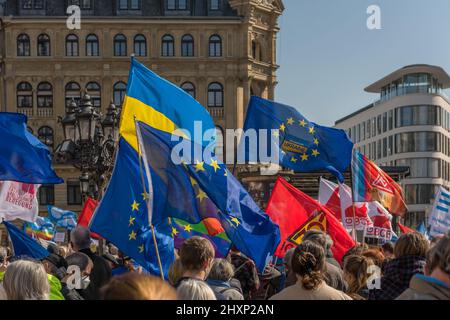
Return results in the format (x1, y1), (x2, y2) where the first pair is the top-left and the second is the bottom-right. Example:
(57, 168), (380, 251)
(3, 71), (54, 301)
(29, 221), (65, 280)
(352, 151), (407, 216)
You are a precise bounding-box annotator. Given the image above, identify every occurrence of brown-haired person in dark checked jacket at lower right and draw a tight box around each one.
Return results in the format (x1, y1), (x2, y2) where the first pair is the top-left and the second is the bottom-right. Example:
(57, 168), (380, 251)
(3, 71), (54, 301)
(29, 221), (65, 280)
(369, 232), (429, 300)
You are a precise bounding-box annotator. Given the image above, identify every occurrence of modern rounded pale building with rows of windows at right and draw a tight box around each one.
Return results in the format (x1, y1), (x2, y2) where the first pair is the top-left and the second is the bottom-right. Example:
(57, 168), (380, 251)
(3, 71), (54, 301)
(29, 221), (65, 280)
(335, 65), (450, 227)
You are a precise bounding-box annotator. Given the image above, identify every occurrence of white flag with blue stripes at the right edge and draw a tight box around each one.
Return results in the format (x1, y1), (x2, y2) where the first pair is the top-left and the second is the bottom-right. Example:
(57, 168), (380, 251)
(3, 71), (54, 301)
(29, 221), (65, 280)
(428, 187), (450, 237)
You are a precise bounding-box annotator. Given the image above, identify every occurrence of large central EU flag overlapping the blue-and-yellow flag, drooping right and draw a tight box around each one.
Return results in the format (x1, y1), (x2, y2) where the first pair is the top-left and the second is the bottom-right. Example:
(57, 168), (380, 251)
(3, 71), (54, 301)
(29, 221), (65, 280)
(137, 122), (280, 271)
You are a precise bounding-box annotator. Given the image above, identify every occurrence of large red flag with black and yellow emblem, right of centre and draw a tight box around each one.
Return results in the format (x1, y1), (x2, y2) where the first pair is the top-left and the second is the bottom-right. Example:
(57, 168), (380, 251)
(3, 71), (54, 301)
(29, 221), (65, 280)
(266, 177), (355, 261)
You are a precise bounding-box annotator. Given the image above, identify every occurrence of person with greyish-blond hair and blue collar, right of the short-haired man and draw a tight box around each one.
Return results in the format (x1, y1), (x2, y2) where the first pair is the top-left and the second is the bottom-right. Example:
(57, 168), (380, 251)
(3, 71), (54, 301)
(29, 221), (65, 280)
(206, 259), (244, 300)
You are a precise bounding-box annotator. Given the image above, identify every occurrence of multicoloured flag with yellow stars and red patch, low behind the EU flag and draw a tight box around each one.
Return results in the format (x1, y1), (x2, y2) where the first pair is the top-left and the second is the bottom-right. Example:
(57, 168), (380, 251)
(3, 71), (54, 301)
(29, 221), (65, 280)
(172, 218), (231, 258)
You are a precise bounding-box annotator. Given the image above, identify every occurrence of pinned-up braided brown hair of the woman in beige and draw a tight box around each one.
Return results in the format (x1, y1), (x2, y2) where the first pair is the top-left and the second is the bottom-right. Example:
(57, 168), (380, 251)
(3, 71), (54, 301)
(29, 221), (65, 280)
(292, 240), (325, 290)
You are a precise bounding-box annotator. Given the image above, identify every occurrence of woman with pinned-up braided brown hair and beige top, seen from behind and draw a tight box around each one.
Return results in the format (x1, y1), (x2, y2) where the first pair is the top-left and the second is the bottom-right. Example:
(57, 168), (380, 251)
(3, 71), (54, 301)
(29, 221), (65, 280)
(270, 240), (351, 300)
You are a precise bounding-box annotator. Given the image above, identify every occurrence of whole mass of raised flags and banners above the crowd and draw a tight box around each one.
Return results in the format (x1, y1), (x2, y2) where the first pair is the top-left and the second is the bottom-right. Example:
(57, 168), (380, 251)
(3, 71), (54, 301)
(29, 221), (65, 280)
(0, 58), (450, 300)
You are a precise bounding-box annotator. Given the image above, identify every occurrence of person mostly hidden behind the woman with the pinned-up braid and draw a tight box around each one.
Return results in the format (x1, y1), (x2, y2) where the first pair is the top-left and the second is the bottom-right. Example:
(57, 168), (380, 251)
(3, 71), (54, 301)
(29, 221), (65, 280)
(302, 230), (347, 291)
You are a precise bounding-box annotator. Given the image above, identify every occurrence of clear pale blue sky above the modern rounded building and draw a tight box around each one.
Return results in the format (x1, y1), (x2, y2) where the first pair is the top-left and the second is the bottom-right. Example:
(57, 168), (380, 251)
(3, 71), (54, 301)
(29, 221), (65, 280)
(276, 0), (450, 125)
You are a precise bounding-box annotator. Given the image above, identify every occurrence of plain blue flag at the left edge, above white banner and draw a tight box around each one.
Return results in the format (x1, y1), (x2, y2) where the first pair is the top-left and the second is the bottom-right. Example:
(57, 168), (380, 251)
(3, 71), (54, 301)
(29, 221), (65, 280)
(0, 112), (63, 184)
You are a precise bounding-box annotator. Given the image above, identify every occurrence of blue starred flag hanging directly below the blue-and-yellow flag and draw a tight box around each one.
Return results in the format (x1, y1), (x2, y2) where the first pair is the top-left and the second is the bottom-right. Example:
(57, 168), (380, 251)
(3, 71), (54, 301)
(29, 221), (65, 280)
(89, 138), (174, 278)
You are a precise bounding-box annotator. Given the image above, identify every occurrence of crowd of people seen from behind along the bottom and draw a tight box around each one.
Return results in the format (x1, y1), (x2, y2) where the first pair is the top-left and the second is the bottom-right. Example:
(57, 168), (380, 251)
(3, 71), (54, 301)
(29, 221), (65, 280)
(0, 227), (450, 300)
